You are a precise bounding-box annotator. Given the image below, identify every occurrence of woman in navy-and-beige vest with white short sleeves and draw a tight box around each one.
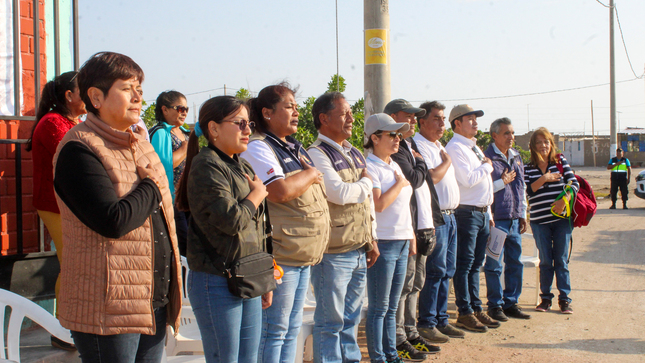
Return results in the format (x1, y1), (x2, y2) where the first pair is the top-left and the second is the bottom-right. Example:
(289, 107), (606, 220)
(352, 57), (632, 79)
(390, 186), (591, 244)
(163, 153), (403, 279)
(241, 83), (330, 363)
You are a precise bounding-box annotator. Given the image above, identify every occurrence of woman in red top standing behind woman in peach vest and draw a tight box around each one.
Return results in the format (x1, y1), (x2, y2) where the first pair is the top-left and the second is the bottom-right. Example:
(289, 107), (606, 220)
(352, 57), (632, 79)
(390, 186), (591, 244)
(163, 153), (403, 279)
(27, 72), (86, 349)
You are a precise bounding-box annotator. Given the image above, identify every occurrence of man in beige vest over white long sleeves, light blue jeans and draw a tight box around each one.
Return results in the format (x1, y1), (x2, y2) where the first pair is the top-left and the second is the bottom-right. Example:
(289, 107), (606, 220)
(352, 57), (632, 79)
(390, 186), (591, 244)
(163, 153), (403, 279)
(308, 92), (379, 363)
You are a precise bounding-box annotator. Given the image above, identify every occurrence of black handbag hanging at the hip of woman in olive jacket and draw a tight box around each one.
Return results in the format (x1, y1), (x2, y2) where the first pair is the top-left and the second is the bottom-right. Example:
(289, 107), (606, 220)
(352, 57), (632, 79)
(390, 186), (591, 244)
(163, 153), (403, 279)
(226, 201), (276, 299)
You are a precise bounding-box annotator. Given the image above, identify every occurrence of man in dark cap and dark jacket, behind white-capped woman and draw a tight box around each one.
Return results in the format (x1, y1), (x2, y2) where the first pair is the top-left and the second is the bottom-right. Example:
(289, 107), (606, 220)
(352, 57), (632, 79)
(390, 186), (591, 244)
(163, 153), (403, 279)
(383, 99), (444, 360)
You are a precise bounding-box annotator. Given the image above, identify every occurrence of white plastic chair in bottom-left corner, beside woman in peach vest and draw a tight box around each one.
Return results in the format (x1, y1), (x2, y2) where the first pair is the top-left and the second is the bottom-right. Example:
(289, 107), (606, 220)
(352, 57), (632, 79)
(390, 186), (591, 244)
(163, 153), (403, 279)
(0, 289), (74, 363)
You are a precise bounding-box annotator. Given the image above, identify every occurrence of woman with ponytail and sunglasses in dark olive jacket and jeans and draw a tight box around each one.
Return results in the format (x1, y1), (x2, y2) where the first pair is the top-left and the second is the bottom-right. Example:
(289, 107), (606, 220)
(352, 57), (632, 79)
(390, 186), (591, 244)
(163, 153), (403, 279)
(176, 96), (273, 363)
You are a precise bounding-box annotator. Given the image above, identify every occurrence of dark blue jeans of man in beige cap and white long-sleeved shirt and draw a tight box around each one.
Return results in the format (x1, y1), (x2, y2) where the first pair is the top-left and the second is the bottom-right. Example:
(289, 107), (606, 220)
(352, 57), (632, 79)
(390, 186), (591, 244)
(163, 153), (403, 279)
(454, 209), (490, 315)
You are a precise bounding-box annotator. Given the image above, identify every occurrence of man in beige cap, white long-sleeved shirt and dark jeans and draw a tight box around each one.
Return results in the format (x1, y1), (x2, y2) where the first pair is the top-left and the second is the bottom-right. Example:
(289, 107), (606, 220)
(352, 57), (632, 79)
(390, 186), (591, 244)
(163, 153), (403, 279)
(446, 105), (500, 332)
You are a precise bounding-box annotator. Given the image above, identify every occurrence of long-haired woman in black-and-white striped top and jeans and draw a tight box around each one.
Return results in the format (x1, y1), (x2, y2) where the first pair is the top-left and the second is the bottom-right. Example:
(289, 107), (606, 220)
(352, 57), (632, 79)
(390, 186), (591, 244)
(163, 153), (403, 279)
(524, 127), (579, 314)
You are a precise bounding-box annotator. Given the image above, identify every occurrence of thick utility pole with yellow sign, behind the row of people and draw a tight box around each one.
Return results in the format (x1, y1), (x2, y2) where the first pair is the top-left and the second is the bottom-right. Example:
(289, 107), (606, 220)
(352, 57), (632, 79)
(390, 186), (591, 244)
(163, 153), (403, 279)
(363, 0), (391, 118)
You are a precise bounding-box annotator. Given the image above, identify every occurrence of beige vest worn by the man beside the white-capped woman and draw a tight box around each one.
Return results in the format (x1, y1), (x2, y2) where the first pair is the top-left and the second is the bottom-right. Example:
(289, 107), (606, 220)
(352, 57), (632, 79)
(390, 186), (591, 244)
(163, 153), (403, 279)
(309, 139), (372, 253)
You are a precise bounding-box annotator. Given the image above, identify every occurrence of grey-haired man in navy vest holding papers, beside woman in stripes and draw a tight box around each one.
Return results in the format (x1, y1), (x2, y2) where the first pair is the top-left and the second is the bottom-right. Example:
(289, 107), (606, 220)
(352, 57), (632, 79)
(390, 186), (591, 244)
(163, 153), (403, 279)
(484, 117), (531, 321)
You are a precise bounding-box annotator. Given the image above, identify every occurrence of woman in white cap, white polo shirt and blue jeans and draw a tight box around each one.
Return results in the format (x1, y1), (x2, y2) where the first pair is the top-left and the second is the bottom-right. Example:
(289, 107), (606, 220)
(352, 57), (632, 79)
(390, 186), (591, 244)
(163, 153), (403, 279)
(365, 113), (414, 362)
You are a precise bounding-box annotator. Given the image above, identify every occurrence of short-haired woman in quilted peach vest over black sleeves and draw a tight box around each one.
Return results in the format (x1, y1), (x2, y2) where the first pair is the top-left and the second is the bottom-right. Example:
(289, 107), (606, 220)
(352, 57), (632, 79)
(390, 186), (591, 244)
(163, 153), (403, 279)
(54, 52), (181, 363)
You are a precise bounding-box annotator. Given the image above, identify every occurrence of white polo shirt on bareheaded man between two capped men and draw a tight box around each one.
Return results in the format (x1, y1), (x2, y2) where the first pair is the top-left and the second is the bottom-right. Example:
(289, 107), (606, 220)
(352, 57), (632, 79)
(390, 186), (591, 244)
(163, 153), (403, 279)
(412, 133), (459, 210)
